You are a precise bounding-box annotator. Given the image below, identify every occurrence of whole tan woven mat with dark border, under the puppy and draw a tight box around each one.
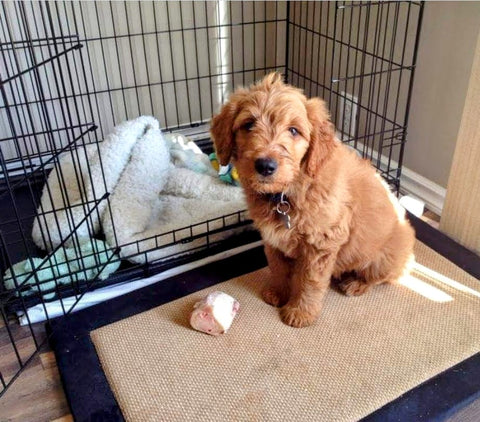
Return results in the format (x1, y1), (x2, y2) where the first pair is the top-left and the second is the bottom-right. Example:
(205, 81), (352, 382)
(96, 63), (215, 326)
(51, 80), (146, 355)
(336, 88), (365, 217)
(47, 217), (480, 421)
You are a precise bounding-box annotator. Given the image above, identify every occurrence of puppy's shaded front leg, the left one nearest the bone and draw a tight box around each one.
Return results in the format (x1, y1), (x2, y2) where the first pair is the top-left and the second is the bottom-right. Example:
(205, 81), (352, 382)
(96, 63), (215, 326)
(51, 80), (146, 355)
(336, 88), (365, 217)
(262, 245), (292, 307)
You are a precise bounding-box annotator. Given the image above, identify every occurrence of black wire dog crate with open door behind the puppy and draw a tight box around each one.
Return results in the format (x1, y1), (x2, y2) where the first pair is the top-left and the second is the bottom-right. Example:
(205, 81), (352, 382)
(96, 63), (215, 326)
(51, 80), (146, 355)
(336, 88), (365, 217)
(0, 1), (423, 394)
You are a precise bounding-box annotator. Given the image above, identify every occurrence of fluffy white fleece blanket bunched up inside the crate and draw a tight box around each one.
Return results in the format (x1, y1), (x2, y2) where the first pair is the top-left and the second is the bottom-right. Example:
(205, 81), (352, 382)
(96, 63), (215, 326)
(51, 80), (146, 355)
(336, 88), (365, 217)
(32, 116), (248, 263)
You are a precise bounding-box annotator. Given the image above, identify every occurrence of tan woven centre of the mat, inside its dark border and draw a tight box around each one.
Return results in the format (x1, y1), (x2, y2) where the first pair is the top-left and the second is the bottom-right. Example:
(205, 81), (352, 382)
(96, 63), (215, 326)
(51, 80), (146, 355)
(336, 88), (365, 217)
(91, 242), (480, 421)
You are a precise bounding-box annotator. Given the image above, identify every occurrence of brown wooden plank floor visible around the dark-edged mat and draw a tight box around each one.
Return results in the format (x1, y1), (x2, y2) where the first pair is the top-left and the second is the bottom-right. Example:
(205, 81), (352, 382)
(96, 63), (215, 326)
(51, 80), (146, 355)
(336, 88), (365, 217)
(0, 211), (480, 422)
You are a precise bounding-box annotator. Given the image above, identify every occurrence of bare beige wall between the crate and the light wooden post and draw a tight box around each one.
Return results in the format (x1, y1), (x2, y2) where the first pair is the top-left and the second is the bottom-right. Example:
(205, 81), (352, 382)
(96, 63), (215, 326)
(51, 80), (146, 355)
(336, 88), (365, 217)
(404, 1), (480, 188)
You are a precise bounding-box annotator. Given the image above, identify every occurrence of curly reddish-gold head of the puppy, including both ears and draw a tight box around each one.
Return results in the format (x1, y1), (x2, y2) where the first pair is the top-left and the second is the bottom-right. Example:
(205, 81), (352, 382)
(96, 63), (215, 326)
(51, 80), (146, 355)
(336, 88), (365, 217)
(211, 73), (334, 193)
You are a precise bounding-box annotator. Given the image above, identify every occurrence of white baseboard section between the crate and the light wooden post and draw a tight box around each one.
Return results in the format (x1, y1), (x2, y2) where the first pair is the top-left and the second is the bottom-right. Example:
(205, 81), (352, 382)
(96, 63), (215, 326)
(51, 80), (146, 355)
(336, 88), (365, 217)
(400, 167), (447, 215)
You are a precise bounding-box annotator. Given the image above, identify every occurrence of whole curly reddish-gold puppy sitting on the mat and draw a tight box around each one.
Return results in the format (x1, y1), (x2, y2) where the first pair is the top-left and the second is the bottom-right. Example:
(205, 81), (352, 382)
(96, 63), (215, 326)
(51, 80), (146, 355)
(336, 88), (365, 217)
(211, 73), (415, 327)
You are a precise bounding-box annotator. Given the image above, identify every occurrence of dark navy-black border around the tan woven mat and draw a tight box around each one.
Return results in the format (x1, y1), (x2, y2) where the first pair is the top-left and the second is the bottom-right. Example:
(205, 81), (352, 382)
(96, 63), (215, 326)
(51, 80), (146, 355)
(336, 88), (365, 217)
(47, 216), (480, 422)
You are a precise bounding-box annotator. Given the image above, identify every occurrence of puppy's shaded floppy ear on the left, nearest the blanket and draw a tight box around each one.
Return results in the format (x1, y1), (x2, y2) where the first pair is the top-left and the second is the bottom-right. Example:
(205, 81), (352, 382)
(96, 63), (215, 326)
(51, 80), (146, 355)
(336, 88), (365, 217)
(210, 101), (237, 166)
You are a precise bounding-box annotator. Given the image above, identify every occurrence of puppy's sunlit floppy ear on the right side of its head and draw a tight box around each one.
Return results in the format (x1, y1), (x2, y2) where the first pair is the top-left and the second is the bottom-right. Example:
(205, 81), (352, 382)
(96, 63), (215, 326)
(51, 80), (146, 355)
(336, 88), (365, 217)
(303, 98), (335, 177)
